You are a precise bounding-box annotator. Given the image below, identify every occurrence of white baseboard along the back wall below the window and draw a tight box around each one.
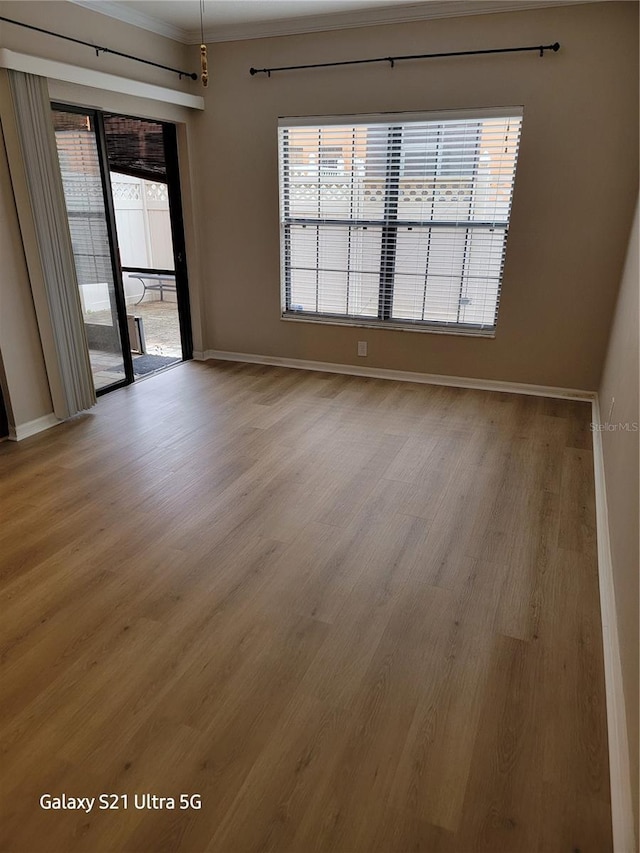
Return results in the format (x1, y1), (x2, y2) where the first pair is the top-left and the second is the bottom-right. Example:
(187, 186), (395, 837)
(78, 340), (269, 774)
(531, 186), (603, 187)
(193, 350), (595, 402)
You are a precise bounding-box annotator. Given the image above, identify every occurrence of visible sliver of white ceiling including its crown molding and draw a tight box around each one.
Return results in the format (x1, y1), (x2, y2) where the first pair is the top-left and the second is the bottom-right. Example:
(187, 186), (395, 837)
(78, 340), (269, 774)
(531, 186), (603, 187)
(72, 0), (595, 44)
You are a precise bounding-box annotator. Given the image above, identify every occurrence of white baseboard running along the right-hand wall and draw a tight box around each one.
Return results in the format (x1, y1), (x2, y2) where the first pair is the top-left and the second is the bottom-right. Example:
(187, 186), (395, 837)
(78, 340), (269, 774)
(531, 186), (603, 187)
(591, 397), (637, 853)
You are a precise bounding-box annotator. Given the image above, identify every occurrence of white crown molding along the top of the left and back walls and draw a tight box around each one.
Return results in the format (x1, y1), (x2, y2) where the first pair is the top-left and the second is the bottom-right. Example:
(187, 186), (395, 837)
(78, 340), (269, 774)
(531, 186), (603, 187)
(70, 0), (598, 45)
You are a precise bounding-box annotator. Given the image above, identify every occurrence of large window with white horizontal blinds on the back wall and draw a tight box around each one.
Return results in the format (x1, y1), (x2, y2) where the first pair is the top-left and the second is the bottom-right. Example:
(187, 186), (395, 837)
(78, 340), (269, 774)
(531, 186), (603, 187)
(279, 107), (522, 335)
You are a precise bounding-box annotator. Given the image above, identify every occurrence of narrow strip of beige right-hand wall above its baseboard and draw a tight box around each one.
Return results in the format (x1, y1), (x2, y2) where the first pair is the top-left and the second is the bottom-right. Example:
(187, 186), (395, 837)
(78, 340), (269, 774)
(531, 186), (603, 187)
(600, 196), (640, 839)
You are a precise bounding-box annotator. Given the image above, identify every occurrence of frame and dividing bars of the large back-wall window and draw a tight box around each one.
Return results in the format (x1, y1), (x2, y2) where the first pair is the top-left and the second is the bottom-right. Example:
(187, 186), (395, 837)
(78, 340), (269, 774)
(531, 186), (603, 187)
(278, 106), (524, 338)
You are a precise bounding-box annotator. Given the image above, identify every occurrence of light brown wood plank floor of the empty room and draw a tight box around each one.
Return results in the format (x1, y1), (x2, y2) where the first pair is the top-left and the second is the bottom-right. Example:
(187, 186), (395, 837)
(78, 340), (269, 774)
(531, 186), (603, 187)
(0, 363), (612, 853)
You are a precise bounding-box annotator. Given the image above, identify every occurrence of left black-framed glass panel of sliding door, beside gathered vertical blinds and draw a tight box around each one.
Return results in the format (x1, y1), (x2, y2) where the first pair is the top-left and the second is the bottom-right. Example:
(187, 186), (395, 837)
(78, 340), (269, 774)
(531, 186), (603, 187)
(53, 107), (133, 393)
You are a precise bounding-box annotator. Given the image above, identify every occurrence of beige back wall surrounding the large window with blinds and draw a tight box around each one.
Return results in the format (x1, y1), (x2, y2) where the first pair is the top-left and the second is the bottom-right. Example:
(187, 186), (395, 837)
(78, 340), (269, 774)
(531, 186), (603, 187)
(191, 2), (638, 389)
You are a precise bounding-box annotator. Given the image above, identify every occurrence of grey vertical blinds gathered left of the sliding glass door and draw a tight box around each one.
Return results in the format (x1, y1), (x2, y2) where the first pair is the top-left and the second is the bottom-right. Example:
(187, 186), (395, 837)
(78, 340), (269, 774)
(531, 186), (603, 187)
(9, 71), (96, 418)
